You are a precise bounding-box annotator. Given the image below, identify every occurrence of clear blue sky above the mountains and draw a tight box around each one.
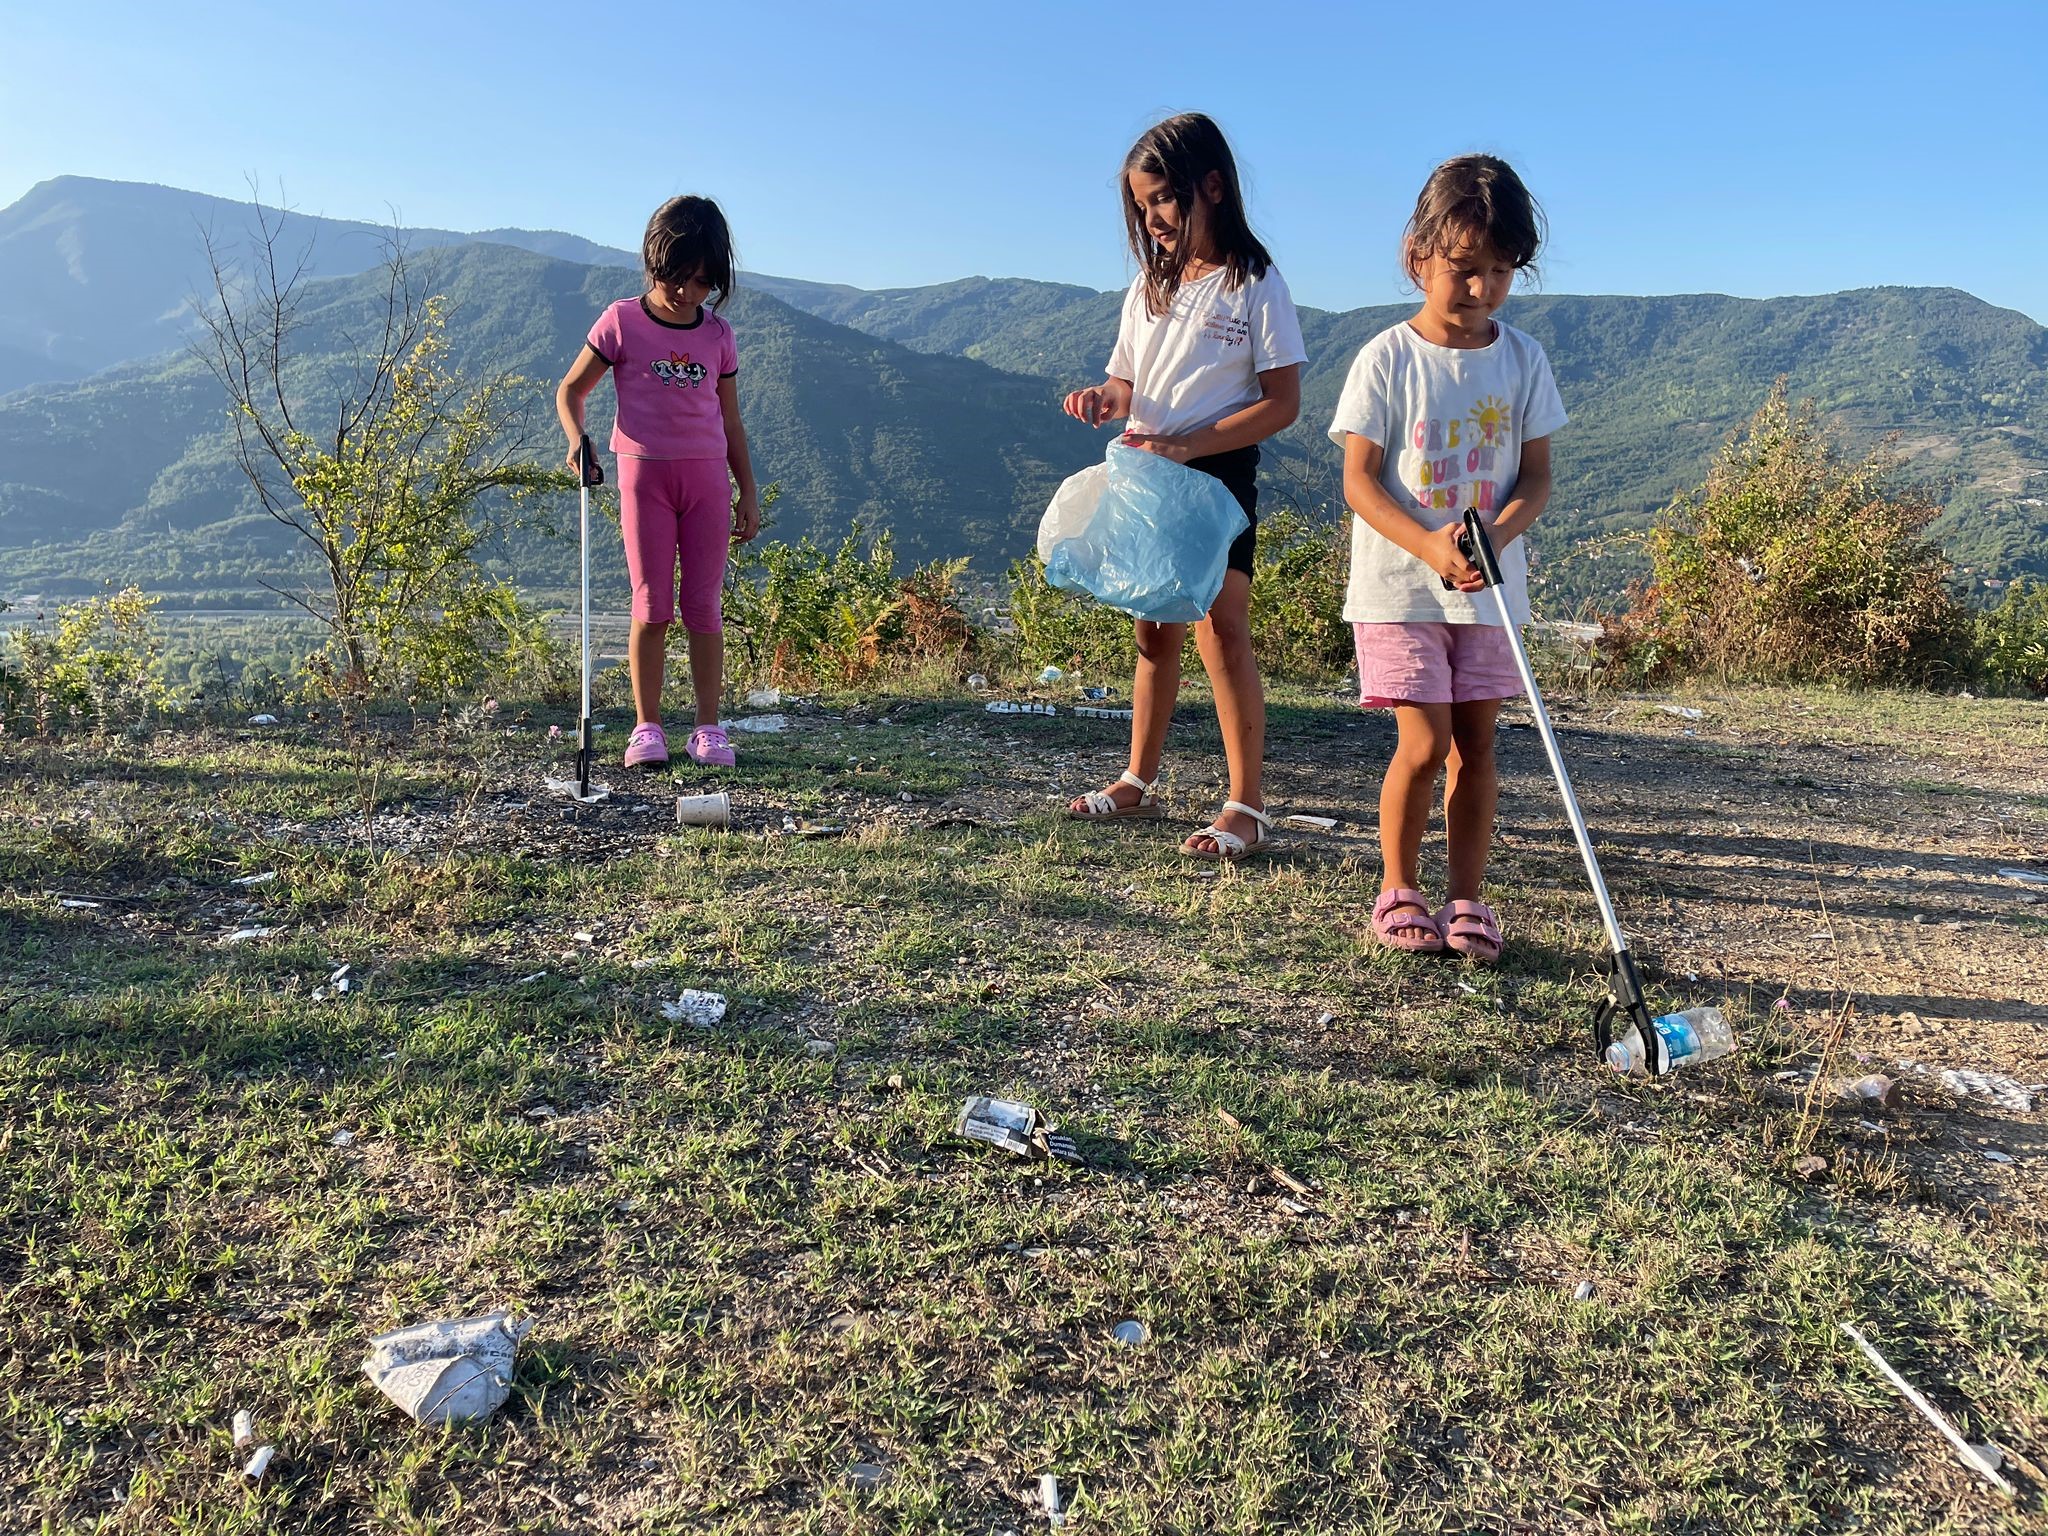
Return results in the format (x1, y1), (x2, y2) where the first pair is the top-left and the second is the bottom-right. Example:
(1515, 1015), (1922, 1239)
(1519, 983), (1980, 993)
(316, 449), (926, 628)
(0, 0), (2048, 322)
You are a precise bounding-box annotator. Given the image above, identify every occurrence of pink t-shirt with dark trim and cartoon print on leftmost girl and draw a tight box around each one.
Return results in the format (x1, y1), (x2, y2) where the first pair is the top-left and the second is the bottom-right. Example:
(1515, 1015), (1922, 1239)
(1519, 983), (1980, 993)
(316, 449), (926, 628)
(588, 299), (739, 459)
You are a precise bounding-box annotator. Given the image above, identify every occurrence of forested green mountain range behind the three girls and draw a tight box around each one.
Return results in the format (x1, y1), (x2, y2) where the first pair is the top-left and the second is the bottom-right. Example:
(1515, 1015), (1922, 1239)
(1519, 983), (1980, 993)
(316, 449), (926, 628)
(0, 176), (2048, 606)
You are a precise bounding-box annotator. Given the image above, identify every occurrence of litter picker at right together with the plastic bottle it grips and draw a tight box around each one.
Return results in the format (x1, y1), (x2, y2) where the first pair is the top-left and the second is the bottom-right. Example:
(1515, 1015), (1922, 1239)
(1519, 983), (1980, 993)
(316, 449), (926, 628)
(1444, 508), (1735, 1075)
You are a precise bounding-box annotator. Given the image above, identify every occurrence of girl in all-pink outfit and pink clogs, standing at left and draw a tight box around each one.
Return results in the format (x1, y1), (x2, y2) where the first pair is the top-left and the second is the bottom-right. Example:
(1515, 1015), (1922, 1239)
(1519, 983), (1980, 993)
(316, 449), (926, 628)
(555, 197), (762, 768)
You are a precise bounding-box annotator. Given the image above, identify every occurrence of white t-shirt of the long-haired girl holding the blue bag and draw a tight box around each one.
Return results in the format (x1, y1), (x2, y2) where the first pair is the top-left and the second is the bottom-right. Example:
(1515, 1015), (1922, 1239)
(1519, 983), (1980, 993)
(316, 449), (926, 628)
(1108, 266), (1309, 436)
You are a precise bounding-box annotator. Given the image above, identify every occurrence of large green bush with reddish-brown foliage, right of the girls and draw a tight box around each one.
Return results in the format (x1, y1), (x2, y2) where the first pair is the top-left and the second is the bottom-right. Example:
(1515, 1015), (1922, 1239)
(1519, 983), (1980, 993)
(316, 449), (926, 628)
(1618, 381), (1970, 684)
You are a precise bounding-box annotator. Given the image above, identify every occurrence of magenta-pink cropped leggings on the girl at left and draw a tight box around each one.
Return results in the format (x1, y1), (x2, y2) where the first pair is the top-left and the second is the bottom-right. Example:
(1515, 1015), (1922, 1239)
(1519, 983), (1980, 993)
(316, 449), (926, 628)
(618, 455), (733, 635)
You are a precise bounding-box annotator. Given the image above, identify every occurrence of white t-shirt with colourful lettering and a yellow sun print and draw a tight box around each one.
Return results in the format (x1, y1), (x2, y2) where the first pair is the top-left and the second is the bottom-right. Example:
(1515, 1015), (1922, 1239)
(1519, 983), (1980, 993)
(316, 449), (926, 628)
(1329, 322), (1565, 625)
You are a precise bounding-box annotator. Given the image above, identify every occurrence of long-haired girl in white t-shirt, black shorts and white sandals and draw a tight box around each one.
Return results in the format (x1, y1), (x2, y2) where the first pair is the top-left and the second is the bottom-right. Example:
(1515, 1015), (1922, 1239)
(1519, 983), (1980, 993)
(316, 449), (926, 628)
(1065, 113), (1307, 860)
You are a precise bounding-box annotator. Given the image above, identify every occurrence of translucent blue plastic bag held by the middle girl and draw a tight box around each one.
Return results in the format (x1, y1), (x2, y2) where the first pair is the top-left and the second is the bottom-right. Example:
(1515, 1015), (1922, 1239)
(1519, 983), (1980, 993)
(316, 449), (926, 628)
(1038, 442), (1251, 625)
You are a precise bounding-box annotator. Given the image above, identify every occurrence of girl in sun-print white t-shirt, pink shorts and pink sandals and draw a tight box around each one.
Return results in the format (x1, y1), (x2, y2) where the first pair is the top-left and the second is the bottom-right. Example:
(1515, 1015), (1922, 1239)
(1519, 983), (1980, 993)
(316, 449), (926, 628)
(1329, 156), (1565, 961)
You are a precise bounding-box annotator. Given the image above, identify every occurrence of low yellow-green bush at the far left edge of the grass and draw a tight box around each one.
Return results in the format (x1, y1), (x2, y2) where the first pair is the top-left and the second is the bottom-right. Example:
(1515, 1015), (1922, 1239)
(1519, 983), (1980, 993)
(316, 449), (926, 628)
(0, 586), (170, 735)
